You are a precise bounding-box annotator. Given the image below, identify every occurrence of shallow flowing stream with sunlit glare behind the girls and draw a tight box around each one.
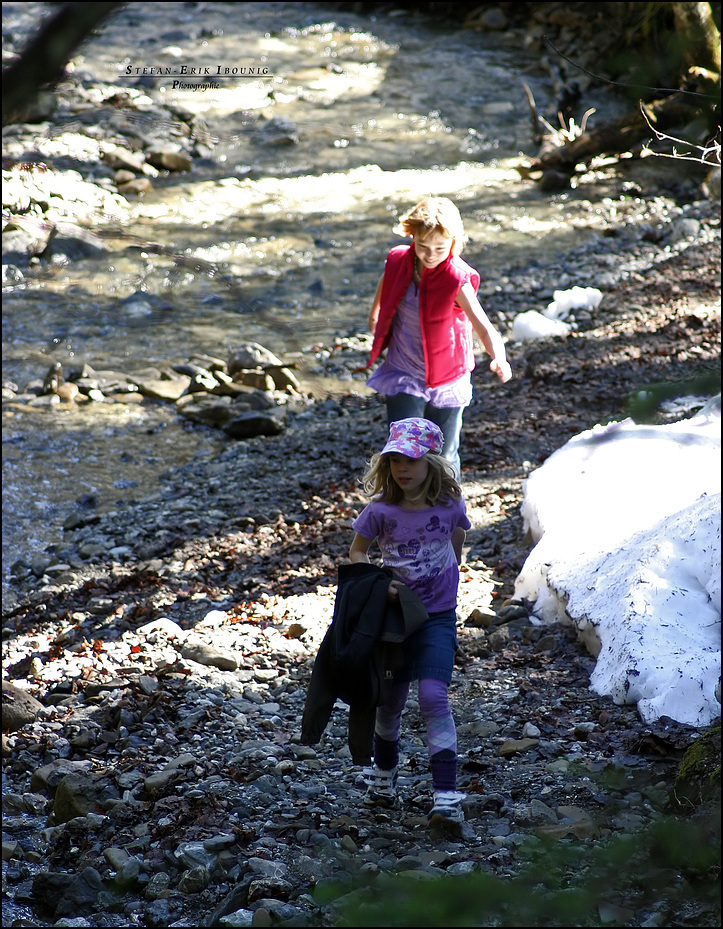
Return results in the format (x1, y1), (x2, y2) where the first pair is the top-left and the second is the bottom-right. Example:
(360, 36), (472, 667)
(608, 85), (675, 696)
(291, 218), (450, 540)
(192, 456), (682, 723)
(3, 2), (688, 599)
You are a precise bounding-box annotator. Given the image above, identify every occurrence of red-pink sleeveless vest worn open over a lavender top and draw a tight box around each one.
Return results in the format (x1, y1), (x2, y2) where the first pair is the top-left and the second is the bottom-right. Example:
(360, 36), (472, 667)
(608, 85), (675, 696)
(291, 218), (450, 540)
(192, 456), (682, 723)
(367, 244), (480, 387)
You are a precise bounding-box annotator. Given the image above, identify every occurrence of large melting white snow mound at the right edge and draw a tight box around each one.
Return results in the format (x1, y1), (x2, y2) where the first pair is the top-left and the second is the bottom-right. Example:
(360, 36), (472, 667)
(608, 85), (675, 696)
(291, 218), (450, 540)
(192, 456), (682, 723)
(515, 398), (721, 727)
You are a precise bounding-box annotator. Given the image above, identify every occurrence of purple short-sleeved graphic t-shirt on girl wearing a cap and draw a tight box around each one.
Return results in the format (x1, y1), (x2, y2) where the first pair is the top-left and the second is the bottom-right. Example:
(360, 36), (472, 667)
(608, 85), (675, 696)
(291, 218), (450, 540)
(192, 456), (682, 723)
(352, 500), (471, 613)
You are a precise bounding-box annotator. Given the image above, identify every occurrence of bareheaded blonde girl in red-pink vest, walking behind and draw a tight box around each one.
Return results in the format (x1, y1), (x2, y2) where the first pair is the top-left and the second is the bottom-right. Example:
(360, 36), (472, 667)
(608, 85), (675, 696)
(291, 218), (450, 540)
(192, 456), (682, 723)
(367, 197), (512, 480)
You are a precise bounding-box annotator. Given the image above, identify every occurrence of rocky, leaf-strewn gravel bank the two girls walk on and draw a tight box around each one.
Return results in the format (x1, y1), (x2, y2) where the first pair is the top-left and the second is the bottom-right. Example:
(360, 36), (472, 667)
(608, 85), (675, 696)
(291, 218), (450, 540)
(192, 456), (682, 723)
(3, 5), (720, 926)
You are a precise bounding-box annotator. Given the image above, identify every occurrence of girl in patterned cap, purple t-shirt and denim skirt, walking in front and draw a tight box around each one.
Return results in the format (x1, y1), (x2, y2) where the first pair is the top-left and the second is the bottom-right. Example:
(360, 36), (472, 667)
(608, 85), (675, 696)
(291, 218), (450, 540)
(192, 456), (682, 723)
(349, 417), (470, 831)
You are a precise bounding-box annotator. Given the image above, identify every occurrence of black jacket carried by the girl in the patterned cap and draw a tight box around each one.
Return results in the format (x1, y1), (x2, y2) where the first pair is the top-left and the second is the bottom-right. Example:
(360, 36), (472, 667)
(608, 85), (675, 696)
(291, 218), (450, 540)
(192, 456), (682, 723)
(301, 562), (428, 764)
